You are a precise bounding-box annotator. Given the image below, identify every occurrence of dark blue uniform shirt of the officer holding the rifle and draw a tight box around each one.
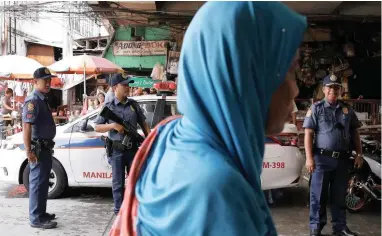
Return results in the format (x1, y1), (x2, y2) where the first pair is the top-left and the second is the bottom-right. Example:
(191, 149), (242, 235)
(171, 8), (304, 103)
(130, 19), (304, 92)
(95, 97), (146, 141)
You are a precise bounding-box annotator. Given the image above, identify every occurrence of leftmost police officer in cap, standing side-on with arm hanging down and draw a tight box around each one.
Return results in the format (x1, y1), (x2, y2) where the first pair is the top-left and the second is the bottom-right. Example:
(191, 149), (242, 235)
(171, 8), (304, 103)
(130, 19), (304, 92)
(22, 67), (57, 229)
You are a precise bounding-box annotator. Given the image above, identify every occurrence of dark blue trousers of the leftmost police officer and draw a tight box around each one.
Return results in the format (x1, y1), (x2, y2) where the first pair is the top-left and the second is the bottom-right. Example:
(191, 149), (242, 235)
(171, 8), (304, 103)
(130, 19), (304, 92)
(29, 149), (52, 224)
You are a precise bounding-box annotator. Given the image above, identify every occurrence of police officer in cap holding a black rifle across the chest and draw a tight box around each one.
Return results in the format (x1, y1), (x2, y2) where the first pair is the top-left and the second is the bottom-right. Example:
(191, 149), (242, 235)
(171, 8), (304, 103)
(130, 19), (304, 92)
(95, 74), (150, 214)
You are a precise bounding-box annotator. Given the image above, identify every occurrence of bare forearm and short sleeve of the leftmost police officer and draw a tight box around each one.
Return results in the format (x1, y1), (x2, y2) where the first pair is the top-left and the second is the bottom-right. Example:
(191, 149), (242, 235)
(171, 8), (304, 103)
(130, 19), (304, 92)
(22, 100), (39, 152)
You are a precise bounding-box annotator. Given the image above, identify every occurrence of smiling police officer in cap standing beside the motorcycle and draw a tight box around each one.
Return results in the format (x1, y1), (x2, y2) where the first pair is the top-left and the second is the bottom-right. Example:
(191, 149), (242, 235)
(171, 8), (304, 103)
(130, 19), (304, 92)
(303, 75), (363, 236)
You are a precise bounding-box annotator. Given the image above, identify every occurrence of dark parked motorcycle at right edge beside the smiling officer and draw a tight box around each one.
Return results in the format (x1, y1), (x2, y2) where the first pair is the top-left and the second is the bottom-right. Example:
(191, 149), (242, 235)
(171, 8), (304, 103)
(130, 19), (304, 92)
(346, 136), (381, 213)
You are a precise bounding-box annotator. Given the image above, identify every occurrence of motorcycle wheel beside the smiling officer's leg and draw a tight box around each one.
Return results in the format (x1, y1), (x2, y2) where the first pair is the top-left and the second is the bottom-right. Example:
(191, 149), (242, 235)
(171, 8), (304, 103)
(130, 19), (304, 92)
(345, 174), (368, 213)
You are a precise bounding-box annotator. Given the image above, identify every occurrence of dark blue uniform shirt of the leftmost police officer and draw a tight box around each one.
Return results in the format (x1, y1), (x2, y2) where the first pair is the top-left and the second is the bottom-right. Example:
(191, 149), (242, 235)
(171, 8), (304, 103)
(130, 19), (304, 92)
(22, 90), (56, 139)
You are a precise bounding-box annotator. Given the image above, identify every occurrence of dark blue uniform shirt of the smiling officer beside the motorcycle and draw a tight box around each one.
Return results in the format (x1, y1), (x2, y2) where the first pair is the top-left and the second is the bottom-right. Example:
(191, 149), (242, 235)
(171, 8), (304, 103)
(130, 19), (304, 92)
(303, 100), (360, 151)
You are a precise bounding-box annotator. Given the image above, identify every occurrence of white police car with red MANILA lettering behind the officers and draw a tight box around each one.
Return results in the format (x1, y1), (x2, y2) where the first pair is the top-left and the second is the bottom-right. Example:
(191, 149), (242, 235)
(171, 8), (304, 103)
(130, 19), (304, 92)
(0, 95), (304, 198)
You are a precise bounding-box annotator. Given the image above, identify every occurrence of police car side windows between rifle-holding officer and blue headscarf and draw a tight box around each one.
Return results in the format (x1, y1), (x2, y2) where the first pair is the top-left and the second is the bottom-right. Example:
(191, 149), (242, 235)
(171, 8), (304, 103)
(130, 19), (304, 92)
(139, 101), (179, 127)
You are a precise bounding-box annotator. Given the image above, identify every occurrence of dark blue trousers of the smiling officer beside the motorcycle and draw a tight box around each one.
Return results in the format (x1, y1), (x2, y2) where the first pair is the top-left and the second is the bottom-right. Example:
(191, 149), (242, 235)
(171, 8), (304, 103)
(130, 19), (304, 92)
(309, 155), (349, 231)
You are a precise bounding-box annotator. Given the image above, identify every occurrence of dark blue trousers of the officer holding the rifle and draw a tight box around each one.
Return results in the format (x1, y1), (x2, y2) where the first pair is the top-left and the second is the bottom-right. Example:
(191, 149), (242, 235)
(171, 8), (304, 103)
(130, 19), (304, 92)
(110, 150), (135, 213)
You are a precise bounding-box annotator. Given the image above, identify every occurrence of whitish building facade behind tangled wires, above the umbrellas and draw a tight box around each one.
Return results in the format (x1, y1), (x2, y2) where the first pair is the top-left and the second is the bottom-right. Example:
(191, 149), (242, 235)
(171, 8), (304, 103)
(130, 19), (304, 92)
(0, 1), (108, 63)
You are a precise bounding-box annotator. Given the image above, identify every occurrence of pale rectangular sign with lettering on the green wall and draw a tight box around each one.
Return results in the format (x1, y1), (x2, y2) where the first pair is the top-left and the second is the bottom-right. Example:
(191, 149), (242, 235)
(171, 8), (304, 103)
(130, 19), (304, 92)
(113, 41), (168, 56)
